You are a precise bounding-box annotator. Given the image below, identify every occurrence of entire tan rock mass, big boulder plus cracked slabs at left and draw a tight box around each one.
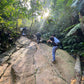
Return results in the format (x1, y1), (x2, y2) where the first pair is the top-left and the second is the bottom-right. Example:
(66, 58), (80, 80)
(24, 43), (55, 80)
(0, 37), (75, 84)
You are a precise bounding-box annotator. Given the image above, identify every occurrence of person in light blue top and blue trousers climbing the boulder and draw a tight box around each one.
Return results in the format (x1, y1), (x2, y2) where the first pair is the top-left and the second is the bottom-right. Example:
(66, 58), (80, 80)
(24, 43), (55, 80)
(47, 35), (60, 63)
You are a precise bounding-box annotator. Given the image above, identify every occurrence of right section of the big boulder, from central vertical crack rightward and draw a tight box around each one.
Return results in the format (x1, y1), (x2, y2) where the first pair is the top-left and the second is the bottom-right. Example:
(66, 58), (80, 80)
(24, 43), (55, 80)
(35, 44), (75, 84)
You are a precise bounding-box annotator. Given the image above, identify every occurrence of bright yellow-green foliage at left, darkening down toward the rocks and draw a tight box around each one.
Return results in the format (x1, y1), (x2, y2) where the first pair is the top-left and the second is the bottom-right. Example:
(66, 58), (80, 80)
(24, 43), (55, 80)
(0, 0), (41, 50)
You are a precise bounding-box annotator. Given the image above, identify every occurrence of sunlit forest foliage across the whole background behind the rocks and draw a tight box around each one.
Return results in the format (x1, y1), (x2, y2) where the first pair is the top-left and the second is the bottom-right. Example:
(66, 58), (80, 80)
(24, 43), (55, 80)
(0, 0), (84, 59)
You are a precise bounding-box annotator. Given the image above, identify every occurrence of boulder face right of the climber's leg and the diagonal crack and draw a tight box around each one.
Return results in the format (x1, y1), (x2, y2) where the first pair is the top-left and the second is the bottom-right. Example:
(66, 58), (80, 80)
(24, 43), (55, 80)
(56, 49), (75, 83)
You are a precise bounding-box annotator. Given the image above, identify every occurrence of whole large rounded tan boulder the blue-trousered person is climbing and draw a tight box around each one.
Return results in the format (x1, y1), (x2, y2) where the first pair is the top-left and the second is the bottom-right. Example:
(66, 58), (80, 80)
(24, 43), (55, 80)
(12, 43), (75, 84)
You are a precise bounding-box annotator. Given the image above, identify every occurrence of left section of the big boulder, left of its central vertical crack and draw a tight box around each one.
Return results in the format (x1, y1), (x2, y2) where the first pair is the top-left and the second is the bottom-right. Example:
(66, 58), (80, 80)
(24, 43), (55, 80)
(12, 43), (36, 84)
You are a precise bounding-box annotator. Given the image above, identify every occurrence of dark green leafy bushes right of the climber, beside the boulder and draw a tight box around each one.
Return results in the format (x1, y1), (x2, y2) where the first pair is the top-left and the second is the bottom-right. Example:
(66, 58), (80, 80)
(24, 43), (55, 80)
(62, 36), (84, 55)
